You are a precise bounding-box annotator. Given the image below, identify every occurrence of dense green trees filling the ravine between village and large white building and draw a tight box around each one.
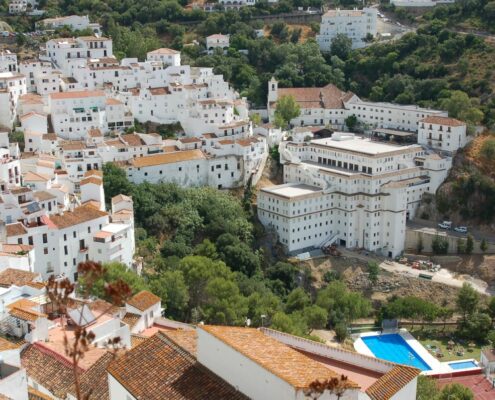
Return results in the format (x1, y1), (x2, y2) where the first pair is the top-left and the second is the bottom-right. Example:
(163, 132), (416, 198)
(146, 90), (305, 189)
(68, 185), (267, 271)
(101, 164), (371, 337)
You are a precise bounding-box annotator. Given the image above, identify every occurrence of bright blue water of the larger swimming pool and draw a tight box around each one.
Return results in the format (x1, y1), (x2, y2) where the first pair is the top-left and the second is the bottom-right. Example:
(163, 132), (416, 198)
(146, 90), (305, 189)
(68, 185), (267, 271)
(361, 333), (431, 371)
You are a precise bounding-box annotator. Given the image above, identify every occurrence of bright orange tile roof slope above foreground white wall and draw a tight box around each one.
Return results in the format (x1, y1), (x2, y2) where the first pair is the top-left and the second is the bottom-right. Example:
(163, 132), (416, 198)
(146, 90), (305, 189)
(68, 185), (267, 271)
(199, 326), (358, 389)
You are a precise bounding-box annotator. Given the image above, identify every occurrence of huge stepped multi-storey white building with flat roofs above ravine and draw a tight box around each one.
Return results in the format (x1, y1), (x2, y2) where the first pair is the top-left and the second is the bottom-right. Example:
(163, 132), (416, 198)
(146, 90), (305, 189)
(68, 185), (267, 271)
(258, 133), (452, 257)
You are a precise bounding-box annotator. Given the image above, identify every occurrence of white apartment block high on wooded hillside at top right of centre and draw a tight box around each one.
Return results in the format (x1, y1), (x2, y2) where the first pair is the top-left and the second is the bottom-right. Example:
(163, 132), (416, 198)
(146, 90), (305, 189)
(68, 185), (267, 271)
(316, 8), (377, 52)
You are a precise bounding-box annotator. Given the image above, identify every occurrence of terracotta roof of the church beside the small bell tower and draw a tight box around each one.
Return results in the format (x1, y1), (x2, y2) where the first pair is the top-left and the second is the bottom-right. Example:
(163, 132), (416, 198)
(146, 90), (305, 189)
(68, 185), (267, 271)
(278, 84), (352, 109)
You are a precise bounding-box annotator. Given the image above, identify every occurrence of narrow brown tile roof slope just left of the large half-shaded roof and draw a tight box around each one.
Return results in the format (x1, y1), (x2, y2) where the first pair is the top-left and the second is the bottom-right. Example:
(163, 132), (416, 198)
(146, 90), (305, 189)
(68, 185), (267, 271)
(68, 352), (118, 400)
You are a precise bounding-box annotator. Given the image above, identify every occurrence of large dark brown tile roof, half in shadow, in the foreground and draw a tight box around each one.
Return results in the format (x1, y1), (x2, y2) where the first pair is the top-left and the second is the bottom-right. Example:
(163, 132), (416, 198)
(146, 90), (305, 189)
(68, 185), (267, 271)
(107, 332), (247, 400)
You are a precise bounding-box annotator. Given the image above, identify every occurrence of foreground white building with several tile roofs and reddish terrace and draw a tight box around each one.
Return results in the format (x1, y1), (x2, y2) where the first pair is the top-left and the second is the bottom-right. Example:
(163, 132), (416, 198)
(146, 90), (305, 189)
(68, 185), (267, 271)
(107, 326), (420, 400)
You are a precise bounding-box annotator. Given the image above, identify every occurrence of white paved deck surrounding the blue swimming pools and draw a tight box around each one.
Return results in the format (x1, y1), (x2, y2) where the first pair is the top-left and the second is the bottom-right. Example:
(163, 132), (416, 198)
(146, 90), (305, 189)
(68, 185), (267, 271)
(354, 329), (479, 375)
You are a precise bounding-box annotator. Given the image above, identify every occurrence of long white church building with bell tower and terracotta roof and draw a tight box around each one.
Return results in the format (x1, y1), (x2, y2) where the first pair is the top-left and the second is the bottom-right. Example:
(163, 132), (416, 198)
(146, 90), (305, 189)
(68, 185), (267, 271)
(267, 78), (447, 132)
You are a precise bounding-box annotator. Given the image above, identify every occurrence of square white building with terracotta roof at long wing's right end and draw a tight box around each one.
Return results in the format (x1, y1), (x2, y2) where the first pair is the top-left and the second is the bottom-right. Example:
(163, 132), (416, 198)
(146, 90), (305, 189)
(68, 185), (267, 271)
(418, 116), (467, 153)
